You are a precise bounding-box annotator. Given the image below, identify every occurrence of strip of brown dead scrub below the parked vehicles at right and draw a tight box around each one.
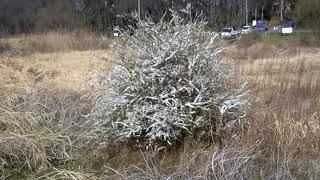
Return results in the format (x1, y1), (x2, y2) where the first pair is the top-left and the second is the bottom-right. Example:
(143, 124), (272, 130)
(227, 32), (319, 60)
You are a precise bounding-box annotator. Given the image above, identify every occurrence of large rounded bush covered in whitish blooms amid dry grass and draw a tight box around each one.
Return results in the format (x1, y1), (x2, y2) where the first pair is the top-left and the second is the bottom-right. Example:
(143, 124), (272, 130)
(94, 10), (248, 145)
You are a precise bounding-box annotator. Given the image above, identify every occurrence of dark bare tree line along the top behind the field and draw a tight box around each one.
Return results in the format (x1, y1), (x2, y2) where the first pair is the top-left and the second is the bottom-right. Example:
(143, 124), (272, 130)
(0, 0), (320, 34)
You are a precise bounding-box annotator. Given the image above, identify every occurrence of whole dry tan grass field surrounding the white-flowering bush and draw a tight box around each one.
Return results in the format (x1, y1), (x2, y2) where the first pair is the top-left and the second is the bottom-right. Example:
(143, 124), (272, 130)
(0, 33), (320, 179)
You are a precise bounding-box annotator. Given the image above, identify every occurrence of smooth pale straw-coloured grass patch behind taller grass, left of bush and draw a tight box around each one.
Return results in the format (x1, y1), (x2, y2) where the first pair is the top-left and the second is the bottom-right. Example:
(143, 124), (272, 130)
(0, 50), (109, 92)
